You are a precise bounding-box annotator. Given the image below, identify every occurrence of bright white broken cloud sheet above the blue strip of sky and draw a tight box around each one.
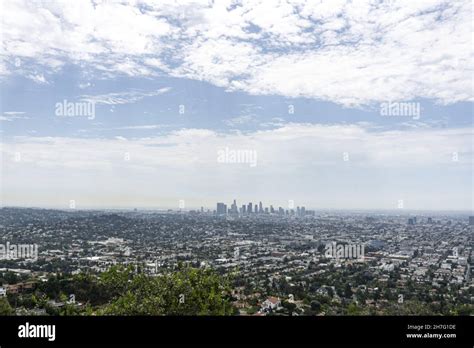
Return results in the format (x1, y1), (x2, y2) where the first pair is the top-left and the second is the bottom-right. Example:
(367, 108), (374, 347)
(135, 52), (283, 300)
(0, 0), (473, 105)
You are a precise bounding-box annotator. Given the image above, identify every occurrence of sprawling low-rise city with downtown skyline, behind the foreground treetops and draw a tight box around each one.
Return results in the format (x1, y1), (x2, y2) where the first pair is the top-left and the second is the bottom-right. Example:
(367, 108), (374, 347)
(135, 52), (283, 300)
(0, 204), (474, 316)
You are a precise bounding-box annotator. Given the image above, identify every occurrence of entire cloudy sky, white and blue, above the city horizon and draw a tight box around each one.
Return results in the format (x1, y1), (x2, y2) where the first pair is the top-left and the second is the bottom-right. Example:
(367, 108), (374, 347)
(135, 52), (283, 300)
(0, 0), (474, 210)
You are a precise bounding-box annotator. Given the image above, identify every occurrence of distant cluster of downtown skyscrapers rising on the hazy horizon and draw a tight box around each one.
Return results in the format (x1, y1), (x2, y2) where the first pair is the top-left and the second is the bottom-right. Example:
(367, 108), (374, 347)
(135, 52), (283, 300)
(215, 199), (315, 217)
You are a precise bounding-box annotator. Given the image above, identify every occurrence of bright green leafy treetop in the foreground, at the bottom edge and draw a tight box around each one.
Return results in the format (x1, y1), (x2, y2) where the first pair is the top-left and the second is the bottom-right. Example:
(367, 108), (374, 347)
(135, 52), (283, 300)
(102, 267), (235, 315)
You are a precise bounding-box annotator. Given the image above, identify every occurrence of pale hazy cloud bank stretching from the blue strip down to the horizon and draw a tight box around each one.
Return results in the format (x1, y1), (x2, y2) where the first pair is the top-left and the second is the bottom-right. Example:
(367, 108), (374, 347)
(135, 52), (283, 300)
(1, 123), (474, 209)
